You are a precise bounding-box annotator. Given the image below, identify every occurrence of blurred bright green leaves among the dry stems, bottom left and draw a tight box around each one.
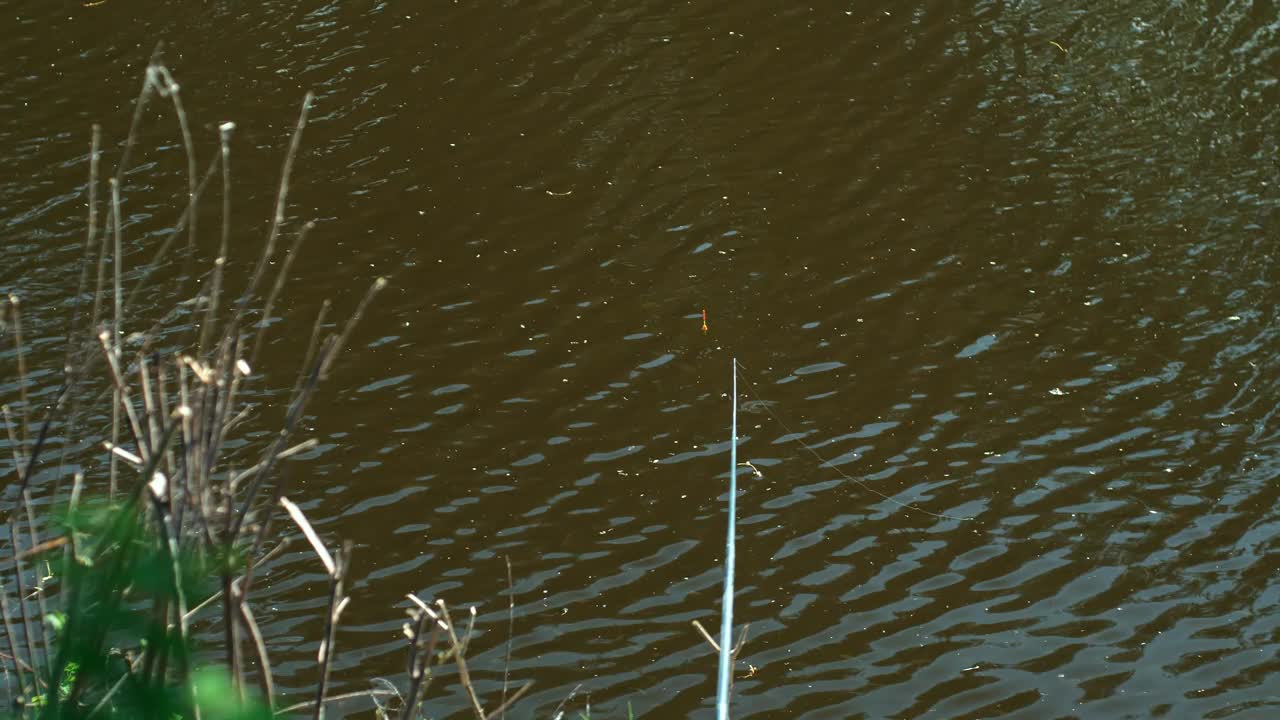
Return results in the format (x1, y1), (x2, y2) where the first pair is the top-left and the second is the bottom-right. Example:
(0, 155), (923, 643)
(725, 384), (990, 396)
(18, 503), (271, 720)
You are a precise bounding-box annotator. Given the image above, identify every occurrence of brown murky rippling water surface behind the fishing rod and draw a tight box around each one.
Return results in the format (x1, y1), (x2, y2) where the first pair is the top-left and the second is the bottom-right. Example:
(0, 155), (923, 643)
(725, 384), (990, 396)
(0, 0), (1280, 719)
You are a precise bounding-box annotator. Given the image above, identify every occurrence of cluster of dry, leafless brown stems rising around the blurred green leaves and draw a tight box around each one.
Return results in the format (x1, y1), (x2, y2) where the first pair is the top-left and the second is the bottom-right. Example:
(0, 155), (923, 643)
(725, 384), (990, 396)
(0, 50), (529, 720)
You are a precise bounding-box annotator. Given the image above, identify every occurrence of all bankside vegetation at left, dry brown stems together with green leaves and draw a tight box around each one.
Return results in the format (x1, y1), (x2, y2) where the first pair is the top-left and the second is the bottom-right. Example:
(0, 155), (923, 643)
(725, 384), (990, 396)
(0, 47), (531, 720)
